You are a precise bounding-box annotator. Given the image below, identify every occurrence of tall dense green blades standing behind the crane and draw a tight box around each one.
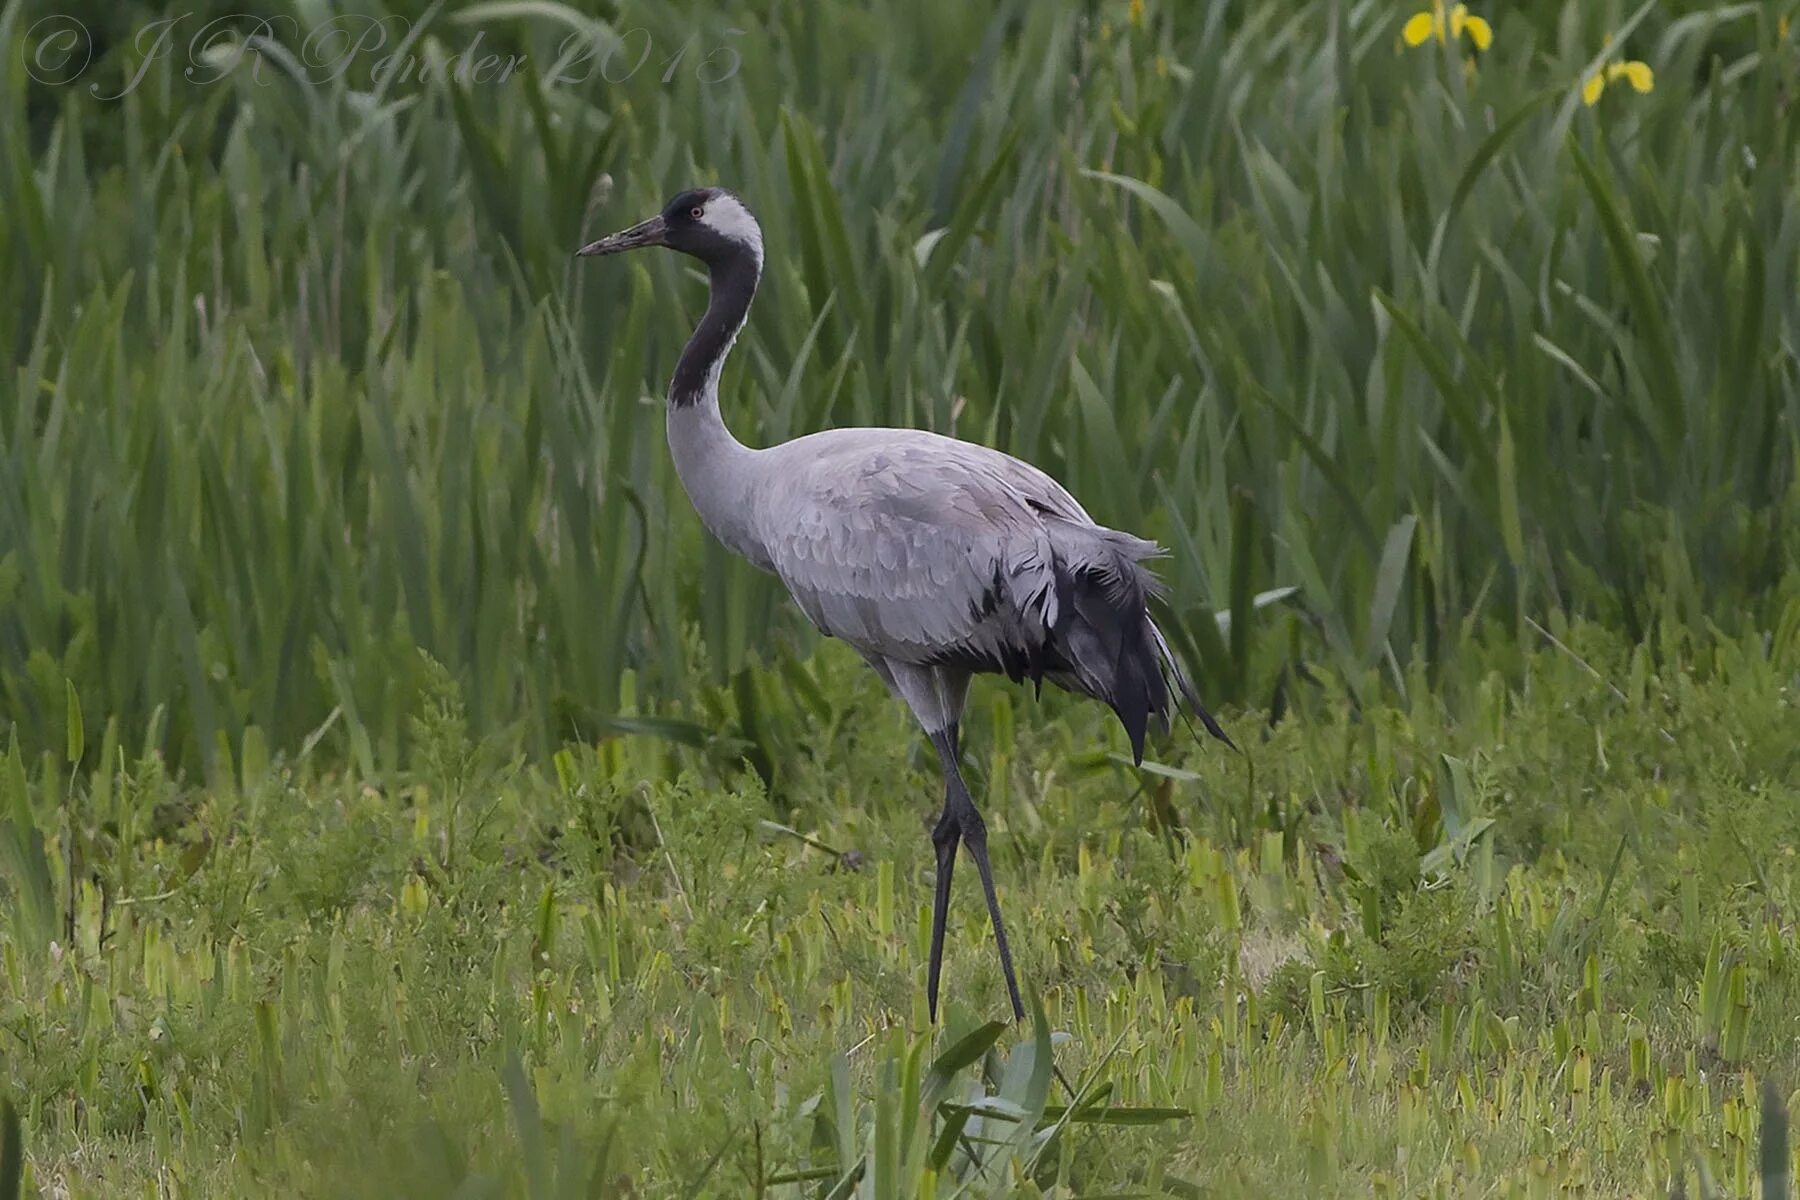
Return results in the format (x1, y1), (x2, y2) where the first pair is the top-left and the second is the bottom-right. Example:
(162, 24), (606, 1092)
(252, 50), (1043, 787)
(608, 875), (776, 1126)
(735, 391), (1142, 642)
(0, 0), (1800, 772)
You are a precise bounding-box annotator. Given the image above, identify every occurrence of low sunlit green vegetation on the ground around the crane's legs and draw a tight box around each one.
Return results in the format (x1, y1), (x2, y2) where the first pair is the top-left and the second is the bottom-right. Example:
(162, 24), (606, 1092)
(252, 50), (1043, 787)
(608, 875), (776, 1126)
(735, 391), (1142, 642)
(0, 628), (1800, 1200)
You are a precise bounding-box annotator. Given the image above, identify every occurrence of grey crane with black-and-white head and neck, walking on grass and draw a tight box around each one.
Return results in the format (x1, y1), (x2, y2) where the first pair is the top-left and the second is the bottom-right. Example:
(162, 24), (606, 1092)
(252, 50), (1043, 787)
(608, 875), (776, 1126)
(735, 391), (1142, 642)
(576, 187), (1231, 1022)
